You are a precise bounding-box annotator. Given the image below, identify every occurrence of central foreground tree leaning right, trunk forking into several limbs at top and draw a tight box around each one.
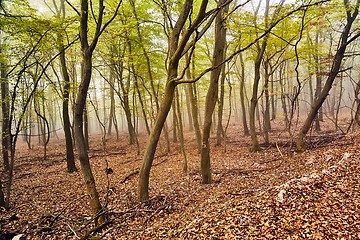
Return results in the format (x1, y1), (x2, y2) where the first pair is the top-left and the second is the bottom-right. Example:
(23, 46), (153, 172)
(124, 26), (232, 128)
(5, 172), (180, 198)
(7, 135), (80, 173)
(138, 0), (219, 202)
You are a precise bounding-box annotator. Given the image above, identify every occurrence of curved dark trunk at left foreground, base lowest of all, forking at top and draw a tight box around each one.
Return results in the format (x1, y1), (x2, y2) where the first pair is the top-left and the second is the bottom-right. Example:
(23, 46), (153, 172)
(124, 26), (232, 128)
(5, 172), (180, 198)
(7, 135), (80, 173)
(74, 0), (121, 225)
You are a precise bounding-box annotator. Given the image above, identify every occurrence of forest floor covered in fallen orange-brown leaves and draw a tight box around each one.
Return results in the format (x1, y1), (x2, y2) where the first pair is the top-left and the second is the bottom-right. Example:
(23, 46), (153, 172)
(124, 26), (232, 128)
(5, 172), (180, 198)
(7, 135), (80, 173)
(0, 123), (360, 239)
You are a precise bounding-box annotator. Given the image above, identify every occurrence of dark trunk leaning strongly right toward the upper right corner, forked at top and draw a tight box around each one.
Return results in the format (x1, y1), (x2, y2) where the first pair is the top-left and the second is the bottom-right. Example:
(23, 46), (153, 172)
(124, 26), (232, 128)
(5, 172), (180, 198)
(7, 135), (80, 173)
(296, 0), (360, 151)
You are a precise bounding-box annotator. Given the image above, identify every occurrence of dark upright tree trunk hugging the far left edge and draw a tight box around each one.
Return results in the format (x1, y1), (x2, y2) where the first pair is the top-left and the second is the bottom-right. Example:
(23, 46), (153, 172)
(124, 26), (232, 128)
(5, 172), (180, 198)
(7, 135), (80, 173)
(0, 62), (10, 171)
